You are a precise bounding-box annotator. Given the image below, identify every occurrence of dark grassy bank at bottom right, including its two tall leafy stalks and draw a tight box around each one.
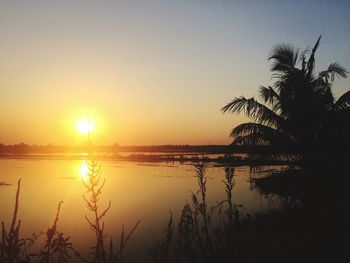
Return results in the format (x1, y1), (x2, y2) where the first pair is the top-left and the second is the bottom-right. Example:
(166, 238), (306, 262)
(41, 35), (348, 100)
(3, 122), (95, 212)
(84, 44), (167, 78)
(150, 165), (348, 263)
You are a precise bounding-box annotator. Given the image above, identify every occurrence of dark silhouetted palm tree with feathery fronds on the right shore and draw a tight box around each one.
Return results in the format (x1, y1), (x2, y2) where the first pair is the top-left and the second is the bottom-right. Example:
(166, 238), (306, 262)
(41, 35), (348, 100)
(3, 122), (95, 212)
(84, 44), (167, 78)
(221, 37), (350, 161)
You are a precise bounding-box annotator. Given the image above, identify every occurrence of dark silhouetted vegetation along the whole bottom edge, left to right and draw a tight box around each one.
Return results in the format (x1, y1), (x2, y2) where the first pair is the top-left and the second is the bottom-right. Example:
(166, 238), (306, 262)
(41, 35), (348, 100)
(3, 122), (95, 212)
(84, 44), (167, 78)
(0, 162), (347, 263)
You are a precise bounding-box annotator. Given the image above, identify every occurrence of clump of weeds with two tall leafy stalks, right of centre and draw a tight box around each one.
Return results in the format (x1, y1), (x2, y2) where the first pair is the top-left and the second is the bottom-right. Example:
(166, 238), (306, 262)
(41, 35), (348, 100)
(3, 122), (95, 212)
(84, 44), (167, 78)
(150, 162), (241, 263)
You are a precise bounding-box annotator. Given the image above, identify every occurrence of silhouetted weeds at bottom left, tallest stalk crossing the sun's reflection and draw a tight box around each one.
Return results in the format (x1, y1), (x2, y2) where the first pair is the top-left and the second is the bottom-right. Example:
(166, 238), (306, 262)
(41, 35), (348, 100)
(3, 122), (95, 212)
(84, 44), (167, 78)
(0, 153), (141, 263)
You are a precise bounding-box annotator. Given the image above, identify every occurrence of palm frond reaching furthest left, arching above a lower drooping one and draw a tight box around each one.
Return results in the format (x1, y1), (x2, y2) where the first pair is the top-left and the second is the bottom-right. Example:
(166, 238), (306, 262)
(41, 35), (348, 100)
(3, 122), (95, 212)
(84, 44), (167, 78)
(221, 96), (283, 127)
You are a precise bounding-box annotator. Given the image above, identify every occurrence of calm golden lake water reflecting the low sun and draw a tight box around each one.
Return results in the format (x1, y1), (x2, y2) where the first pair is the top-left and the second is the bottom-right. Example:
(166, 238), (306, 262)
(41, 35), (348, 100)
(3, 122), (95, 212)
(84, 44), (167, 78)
(0, 159), (280, 262)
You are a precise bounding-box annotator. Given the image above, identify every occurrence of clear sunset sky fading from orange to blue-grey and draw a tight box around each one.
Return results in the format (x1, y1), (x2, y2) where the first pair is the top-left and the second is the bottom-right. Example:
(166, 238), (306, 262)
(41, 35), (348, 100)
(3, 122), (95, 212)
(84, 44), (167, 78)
(0, 0), (350, 145)
